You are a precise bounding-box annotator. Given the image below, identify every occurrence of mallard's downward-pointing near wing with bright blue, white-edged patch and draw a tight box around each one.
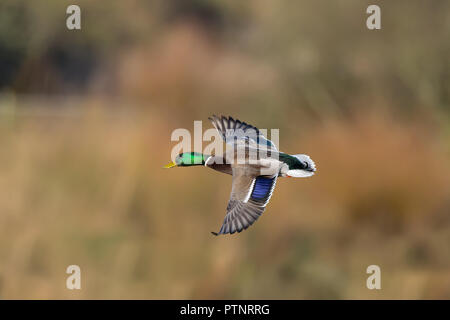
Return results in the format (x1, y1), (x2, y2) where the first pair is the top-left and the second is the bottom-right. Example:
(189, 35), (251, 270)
(213, 168), (278, 235)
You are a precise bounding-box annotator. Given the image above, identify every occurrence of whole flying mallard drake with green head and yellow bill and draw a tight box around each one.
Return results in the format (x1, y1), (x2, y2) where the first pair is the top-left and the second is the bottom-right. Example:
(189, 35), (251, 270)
(165, 115), (316, 236)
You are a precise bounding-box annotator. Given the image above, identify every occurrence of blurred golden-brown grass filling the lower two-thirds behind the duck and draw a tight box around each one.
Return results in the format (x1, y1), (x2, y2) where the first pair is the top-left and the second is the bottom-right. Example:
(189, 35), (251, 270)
(0, 99), (450, 299)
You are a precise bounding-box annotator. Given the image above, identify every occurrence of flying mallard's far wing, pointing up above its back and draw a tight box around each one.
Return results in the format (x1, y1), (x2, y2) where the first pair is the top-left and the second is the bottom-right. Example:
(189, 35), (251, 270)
(209, 115), (277, 150)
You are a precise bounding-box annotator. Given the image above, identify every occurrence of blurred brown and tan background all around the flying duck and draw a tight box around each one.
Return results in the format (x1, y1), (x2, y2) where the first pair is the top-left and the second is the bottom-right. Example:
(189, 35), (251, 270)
(0, 0), (450, 299)
